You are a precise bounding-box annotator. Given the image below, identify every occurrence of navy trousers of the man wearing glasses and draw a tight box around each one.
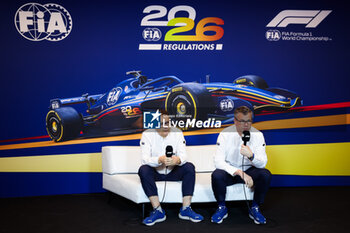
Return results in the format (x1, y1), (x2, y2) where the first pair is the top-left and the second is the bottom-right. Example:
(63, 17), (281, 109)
(211, 167), (271, 205)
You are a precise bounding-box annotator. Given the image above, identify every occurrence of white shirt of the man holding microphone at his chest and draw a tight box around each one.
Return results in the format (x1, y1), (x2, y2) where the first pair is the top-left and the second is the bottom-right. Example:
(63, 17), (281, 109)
(140, 127), (187, 174)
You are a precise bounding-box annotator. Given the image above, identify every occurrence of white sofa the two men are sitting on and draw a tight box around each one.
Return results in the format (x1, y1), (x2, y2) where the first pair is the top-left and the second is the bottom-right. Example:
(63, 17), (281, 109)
(102, 145), (254, 206)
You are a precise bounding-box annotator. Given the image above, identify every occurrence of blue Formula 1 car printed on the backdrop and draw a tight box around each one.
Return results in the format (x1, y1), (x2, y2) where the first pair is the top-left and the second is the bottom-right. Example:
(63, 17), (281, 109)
(46, 71), (302, 142)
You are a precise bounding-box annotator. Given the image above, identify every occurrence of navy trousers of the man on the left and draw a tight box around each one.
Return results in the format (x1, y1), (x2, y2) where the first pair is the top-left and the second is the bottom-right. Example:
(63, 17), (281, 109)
(139, 162), (196, 197)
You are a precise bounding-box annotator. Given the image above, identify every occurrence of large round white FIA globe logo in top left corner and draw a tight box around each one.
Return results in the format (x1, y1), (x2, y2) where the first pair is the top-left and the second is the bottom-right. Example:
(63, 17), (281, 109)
(15, 3), (73, 41)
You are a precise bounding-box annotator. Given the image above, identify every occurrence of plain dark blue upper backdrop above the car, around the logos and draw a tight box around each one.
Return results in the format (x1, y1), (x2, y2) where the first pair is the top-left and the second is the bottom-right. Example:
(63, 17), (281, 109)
(0, 0), (350, 139)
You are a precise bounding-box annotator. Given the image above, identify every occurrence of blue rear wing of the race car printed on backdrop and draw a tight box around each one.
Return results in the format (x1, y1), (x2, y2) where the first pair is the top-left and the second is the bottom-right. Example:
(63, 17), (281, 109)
(49, 94), (104, 109)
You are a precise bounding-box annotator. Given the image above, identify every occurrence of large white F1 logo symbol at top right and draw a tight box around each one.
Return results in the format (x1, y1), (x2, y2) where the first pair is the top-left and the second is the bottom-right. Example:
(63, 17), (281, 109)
(266, 10), (332, 28)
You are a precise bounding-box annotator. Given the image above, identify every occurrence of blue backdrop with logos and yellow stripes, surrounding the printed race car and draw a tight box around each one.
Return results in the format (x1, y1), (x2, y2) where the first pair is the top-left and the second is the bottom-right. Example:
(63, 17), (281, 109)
(0, 0), (350, 197)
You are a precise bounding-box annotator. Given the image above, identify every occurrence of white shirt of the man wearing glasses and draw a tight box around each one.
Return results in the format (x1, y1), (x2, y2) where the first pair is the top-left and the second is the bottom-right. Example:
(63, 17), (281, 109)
(214, 125), (267, 176)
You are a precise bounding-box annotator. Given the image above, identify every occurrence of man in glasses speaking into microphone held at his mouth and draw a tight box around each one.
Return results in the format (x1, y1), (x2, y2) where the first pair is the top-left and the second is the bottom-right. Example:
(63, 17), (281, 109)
(211, 106), (271, 224)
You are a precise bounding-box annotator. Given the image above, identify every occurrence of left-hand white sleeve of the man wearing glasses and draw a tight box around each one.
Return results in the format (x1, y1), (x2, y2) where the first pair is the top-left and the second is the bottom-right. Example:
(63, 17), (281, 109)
(214, 133), (238, 176)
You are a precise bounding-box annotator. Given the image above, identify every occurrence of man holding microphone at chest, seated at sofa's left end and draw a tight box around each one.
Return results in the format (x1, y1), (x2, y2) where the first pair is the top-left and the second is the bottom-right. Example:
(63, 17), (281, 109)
(139, 114), (203, 226)
